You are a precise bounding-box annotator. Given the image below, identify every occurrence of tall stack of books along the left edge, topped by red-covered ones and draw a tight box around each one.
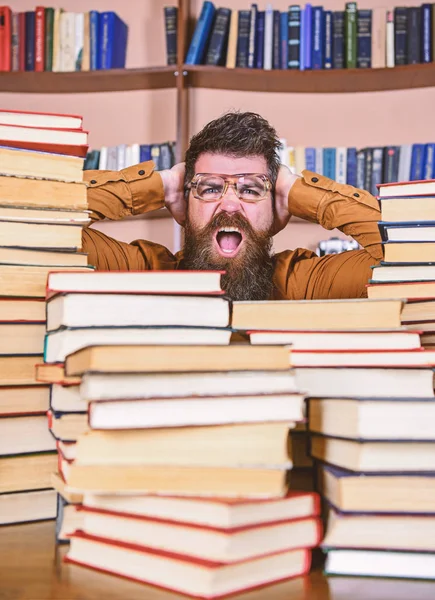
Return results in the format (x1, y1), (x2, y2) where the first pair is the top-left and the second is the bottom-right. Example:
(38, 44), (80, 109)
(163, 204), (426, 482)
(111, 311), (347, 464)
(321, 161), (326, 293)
(0, 111), (89, 524)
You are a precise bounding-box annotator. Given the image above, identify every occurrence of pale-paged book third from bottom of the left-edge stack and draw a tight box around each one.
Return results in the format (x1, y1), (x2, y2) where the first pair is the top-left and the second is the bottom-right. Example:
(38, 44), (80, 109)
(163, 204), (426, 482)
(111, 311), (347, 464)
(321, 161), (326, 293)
(0, 415), (56, 456)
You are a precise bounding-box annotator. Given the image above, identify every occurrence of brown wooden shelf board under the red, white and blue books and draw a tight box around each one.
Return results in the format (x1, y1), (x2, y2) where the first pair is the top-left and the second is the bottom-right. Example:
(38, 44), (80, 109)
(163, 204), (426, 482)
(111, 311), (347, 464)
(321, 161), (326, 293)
(0, 67), (176, 94)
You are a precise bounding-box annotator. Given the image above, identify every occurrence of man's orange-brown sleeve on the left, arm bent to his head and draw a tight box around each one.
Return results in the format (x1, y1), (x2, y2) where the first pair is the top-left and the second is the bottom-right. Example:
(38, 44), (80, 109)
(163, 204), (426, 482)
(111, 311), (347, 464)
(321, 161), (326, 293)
(83, 161), (175, 271)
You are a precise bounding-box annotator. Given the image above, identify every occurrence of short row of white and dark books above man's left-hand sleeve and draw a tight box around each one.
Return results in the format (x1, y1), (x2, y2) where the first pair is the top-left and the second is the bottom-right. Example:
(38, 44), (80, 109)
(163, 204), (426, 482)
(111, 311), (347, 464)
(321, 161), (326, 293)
(84, 142), (175, 171)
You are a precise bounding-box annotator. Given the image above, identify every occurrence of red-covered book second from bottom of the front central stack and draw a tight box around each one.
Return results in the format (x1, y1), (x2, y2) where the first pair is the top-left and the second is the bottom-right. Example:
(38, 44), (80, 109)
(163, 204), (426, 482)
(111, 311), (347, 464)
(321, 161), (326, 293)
(79, 507), (322, 564)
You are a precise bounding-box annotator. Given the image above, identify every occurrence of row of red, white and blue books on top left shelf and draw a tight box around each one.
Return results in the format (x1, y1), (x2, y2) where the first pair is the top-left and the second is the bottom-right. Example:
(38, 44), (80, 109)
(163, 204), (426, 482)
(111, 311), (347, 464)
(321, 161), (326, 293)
(0, 6), (128, 72)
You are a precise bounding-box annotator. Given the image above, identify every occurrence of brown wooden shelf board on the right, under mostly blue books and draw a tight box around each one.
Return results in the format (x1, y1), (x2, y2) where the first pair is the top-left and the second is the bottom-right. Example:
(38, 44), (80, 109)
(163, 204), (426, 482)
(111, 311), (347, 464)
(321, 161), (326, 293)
(185, 63), (435, 94)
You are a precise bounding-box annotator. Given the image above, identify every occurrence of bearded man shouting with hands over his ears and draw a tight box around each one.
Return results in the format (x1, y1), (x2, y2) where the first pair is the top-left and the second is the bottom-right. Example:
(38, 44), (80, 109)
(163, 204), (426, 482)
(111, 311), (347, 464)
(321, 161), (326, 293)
(83, 112), (382, 300)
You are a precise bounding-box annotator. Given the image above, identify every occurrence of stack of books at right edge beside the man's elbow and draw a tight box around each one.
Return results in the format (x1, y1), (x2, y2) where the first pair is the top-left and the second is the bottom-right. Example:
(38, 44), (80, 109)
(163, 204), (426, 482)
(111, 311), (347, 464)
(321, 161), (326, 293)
(368, 180), (435, 347)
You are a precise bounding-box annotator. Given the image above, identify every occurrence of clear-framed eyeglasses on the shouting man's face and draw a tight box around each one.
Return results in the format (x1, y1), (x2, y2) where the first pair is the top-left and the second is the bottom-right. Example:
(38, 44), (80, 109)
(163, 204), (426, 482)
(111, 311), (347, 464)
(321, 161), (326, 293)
(190, 173), (272, 202)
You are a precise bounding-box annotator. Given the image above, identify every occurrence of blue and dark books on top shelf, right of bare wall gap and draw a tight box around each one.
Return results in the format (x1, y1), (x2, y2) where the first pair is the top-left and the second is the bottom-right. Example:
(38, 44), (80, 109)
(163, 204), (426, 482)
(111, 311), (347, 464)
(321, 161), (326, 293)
(172, 0), (435, 70)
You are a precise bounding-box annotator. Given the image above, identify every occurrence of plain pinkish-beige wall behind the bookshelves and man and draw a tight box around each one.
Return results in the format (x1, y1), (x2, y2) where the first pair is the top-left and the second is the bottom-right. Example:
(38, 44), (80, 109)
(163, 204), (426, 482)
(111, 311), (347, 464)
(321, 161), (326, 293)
(0, 0), (435, 255)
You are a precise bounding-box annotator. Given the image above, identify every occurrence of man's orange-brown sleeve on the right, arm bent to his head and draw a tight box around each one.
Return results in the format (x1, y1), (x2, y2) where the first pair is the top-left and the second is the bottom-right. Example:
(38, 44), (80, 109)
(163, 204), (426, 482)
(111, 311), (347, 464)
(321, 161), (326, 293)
(275, 171), (383, 300)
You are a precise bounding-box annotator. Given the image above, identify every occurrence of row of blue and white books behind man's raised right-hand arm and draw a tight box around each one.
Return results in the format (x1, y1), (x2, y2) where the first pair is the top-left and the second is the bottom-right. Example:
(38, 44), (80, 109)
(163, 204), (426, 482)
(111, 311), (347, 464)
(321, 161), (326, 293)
(280, 139), (435, 196)
